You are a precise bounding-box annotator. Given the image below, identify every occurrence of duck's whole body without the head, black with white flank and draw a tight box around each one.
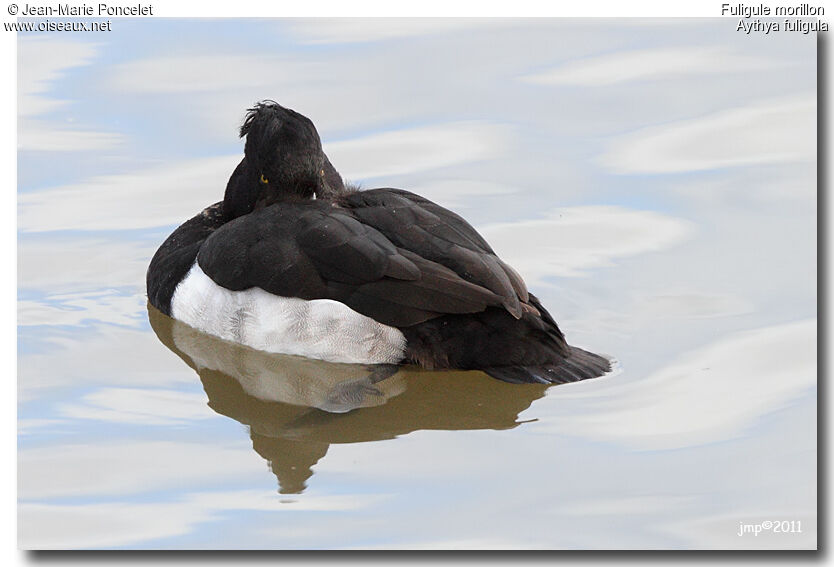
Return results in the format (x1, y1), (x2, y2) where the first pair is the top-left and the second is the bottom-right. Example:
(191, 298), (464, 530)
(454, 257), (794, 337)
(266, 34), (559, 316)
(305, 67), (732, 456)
(148, 189), (609, 382)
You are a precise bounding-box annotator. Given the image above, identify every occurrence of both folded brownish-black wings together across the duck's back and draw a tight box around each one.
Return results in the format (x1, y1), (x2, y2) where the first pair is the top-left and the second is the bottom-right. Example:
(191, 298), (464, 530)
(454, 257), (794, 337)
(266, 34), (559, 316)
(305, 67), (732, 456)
(197, 195), (527, 327)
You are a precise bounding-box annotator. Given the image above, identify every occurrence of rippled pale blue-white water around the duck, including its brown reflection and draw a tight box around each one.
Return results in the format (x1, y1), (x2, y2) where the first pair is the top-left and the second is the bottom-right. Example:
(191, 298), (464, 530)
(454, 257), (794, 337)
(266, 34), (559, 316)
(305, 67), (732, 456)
(18, 19), (817, 549)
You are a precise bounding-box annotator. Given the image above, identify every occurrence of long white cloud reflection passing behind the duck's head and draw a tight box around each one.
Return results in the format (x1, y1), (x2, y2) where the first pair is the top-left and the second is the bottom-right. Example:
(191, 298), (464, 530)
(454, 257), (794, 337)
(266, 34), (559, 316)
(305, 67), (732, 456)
(18, 122), (508, 232)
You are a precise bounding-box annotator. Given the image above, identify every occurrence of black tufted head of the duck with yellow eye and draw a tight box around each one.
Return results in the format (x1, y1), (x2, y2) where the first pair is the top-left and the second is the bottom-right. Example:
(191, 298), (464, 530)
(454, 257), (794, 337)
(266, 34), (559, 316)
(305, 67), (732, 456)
(225, 100), (342, 216)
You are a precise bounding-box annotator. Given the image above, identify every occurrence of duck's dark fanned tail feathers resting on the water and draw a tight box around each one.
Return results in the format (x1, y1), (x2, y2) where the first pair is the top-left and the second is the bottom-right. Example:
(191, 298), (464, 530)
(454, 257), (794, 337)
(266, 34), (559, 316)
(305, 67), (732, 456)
(483, 347), (611, 384)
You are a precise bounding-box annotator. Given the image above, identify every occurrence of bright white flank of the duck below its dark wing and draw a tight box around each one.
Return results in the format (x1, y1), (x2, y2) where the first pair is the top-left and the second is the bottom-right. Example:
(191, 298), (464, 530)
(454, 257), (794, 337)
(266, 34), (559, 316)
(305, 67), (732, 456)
(171, 262), (406, 364)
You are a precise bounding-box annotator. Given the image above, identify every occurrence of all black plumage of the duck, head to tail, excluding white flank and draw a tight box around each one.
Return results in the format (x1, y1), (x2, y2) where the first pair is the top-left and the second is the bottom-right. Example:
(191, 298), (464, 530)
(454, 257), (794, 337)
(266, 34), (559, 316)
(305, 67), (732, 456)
(148, 102), (610, 383)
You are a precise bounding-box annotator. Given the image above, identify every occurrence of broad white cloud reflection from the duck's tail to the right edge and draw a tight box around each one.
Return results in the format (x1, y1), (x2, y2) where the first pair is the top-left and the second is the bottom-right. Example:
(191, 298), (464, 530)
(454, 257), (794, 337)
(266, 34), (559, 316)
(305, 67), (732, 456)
(537, 320), (817, 450)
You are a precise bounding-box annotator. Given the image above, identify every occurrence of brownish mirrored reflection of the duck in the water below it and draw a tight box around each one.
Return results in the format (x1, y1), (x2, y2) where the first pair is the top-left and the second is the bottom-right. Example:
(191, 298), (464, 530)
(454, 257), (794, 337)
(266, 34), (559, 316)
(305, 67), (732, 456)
(148, 305), (548, 494)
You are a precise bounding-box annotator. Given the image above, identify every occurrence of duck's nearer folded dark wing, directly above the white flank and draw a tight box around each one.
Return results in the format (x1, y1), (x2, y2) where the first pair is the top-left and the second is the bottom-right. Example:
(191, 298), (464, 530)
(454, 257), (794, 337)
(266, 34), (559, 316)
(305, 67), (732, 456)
(198, 201), (508, 326)
